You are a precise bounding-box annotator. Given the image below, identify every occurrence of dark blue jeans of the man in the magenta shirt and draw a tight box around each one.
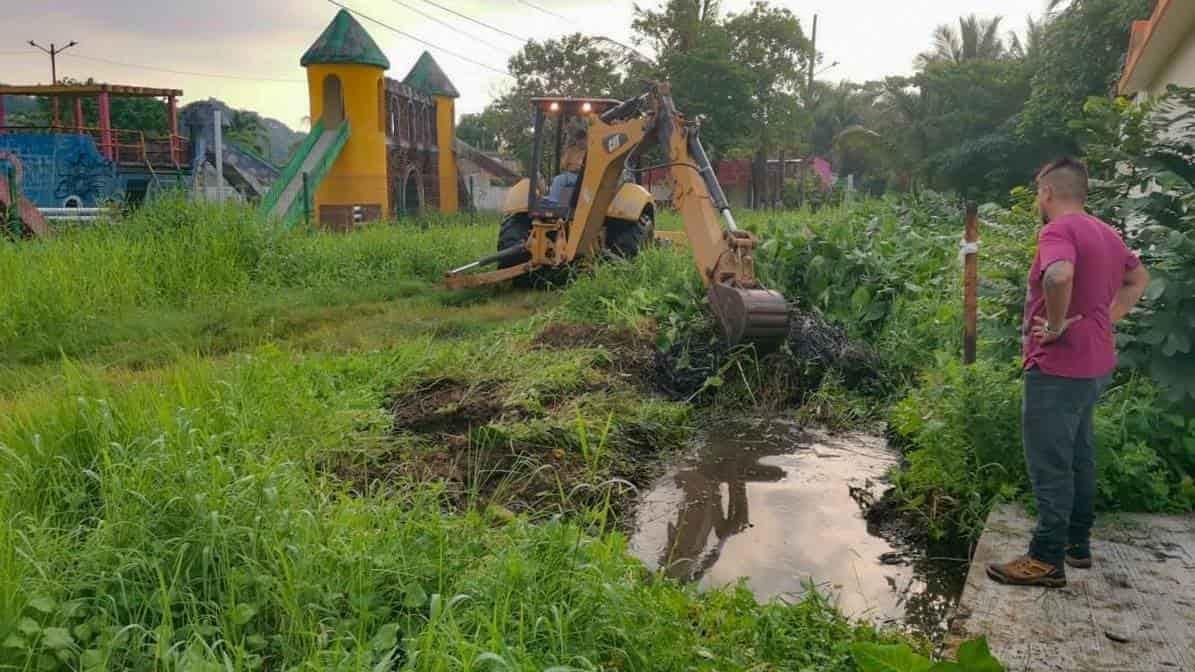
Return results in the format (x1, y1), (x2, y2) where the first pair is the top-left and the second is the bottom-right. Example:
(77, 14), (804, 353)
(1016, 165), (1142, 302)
(1022, 367), (1109, 567)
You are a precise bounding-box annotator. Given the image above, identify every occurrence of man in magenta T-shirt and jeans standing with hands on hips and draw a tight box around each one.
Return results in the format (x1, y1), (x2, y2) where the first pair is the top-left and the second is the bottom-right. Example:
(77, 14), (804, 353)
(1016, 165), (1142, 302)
(987, 158), (1150, 587)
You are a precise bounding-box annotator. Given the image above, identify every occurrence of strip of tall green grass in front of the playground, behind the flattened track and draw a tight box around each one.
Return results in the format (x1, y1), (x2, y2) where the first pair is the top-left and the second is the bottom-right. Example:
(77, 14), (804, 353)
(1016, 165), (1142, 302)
(0, 197), (495, 353)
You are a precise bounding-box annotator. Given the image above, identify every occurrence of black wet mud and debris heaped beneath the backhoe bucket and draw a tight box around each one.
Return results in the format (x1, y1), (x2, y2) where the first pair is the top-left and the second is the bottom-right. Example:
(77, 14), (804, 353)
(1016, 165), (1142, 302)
(652, 308), (878, 403)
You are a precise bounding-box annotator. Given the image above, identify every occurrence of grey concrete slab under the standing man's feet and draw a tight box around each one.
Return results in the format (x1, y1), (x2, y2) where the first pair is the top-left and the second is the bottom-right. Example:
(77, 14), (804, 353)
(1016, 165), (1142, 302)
(951, 506), (1195, 672)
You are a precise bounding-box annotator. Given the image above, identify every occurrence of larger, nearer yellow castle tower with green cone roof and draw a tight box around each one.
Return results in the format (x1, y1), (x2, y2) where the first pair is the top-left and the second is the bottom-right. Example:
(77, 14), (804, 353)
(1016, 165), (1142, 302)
(300, 10), (391, 230)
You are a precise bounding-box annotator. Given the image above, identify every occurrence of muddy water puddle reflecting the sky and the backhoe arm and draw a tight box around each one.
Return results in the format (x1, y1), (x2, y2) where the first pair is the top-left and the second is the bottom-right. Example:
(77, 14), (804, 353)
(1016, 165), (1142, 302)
(631, 420), (966, 639)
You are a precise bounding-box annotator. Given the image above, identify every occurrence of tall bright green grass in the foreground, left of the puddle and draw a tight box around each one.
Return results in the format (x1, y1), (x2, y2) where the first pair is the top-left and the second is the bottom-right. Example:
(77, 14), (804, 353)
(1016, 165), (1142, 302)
(0, 341), (898, 671)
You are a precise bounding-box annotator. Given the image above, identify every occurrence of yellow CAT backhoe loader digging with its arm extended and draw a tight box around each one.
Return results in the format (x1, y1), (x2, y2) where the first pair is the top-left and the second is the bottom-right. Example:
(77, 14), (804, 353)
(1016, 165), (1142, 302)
(445, 84), (789, 348)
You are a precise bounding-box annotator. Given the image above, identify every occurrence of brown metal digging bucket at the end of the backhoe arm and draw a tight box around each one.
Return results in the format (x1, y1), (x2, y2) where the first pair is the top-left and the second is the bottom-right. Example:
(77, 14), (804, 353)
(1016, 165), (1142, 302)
(710, 282), (789, 352)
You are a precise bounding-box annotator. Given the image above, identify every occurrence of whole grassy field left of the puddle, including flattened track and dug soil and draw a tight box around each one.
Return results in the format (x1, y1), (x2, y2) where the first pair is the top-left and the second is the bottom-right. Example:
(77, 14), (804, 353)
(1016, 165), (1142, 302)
(0, 201), (912, 671)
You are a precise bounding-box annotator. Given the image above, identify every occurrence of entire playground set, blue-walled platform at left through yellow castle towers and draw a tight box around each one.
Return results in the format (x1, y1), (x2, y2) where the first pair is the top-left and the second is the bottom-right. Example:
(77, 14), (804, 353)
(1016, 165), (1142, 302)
(0, 10), (485, 231)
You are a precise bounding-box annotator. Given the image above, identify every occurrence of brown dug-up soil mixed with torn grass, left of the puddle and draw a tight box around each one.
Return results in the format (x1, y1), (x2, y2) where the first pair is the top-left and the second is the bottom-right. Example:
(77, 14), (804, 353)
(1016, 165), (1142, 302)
(330, 373), (664, 518)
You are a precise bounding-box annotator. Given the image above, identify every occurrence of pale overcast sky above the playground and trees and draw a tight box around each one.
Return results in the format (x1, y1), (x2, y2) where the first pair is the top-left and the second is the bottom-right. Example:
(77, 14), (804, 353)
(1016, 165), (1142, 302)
(0, 0), (1046, 128)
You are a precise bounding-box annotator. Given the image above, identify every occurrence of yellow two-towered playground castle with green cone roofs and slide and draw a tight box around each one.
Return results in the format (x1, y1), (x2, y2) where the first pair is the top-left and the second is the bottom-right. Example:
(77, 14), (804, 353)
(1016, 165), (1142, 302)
(262, 10), (467, 231)
